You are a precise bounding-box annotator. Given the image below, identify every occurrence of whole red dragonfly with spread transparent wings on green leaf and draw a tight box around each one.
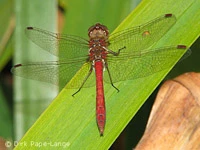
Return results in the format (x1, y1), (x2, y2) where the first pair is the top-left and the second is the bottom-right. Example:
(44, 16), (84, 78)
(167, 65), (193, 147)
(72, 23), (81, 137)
(12, 14), (186, 135)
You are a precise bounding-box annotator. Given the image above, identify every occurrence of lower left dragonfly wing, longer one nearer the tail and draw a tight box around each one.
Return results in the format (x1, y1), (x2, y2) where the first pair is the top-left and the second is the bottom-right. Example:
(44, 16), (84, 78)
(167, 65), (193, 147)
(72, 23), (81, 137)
(11, 60), (94, 88)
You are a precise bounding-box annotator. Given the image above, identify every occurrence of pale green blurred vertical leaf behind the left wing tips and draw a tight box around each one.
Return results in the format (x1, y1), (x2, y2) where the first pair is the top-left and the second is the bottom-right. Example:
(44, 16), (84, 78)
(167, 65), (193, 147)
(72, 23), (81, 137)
(13, 0), (57, 141)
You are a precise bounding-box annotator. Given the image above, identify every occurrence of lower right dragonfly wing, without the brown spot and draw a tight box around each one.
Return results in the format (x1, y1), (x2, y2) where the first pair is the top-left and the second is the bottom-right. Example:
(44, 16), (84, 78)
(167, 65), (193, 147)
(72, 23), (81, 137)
(104, 45), (186, 83)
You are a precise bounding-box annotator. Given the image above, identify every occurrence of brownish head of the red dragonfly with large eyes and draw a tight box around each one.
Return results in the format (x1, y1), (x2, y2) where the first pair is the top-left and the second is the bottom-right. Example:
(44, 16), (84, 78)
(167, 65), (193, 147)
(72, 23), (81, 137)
(88, 23), (109, 39)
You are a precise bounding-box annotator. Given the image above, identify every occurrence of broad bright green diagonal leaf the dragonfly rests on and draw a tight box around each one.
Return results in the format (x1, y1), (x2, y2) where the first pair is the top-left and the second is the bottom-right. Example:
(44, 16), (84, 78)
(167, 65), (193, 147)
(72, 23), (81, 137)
(16, 0), (200, 149)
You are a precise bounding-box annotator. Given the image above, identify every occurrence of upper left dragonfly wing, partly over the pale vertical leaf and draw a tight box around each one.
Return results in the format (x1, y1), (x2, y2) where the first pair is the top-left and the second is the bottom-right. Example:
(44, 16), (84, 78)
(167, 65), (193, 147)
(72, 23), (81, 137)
(25, 27), (89, 59)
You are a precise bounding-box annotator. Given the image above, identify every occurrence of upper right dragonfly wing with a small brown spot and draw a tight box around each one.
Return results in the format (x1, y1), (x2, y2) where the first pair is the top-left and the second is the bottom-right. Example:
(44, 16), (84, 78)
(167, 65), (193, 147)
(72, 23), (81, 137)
(108, 14), (176, 53)
